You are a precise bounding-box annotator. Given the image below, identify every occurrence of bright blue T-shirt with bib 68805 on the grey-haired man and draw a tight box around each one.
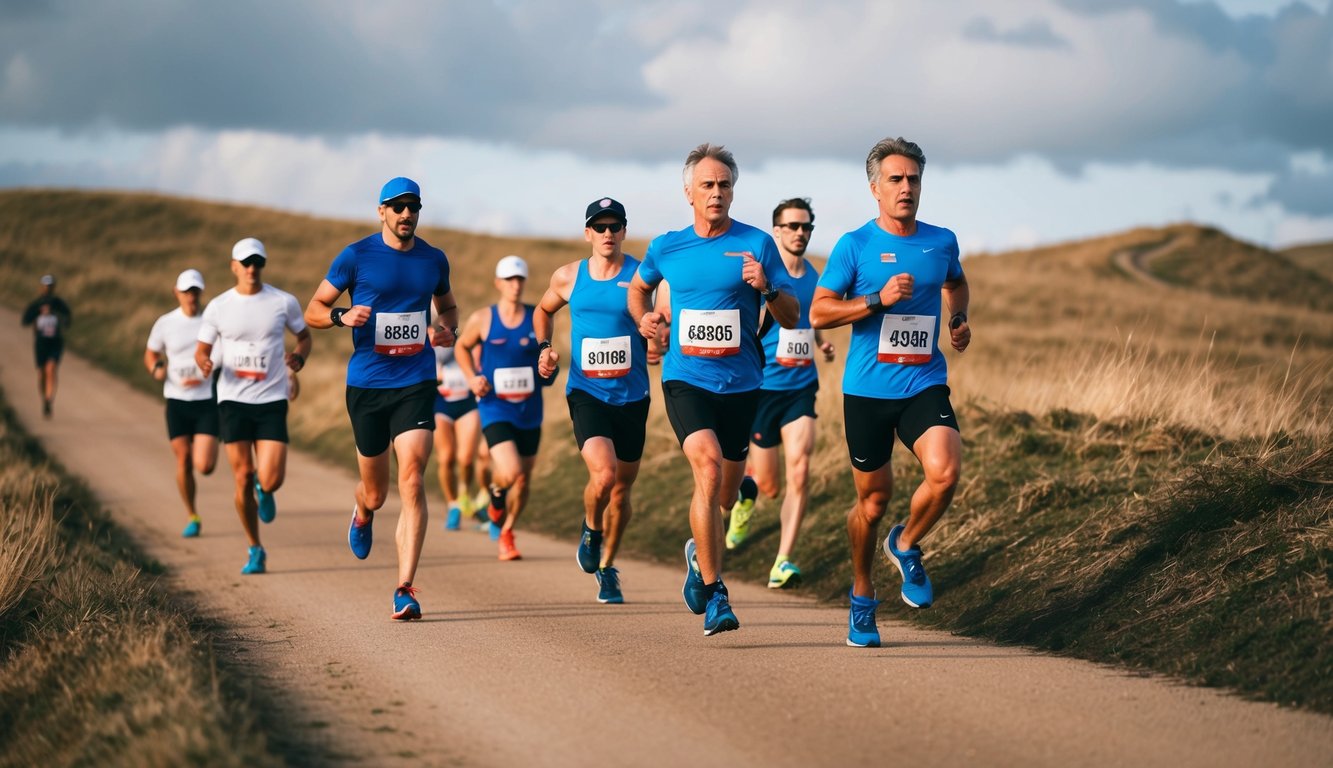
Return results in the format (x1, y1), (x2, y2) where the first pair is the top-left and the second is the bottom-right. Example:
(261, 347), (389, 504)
(639, 220), (792, 395)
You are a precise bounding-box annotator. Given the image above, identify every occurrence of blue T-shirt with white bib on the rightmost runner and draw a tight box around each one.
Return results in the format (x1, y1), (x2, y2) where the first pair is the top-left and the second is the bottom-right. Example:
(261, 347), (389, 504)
(818, 219), (962, 400)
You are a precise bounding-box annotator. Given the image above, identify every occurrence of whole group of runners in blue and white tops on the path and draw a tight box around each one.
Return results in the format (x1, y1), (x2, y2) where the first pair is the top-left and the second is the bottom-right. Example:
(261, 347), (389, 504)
(54, 139), (970, 647)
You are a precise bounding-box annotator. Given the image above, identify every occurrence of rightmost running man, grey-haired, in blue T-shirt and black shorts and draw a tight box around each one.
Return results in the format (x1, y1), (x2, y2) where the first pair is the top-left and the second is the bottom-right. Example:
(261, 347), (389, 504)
(810, 137), (972, 648)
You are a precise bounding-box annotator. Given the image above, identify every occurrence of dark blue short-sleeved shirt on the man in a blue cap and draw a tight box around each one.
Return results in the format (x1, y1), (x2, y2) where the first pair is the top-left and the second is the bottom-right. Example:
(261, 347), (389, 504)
(325, 233), (449, 389)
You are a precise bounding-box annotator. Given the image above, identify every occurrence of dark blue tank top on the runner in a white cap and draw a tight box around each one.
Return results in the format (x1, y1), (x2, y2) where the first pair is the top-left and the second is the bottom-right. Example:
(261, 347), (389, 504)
(477, 304), (541, 429)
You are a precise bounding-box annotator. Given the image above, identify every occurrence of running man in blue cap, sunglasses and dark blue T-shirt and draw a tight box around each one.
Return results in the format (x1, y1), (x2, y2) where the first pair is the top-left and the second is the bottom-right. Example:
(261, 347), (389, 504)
(305, 176), (459, 621)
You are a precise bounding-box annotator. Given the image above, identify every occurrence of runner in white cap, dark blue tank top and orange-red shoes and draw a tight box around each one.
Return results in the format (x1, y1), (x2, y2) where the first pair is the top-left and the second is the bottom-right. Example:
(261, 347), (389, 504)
(455, 256), (553, 560)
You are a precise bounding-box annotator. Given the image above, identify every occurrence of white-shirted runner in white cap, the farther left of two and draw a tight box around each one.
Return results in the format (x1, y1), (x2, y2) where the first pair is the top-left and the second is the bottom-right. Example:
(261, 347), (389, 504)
(144, 269), (221, 539)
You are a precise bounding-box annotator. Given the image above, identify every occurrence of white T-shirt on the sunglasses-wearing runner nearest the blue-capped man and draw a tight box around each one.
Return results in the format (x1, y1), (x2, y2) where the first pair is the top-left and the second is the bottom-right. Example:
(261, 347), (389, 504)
(199, 285), (305, 405)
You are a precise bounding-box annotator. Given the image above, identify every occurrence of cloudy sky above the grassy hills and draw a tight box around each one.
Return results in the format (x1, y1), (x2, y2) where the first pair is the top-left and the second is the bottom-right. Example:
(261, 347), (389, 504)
(0, 0), (1333, 253)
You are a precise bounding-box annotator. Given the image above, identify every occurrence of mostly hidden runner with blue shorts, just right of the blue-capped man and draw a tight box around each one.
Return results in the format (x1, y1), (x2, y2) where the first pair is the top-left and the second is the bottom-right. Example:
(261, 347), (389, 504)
(435, 347), (481, 531)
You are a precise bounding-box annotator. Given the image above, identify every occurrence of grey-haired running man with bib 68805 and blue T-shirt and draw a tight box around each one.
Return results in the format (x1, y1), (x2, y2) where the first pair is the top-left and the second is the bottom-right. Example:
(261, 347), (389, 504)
(628, 144), (798, 635)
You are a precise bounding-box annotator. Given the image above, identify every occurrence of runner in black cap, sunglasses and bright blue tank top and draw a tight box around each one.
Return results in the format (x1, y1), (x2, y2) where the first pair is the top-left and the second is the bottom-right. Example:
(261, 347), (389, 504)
(532, 197), (648, 603)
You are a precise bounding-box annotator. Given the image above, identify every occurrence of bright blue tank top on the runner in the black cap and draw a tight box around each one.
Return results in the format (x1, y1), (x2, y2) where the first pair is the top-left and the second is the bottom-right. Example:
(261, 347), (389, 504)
(565, 253), (648, 405)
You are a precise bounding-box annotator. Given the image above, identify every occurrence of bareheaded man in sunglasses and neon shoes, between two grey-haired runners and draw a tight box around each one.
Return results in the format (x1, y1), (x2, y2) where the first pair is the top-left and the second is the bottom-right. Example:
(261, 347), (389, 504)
(726, 197), (833, 589)
